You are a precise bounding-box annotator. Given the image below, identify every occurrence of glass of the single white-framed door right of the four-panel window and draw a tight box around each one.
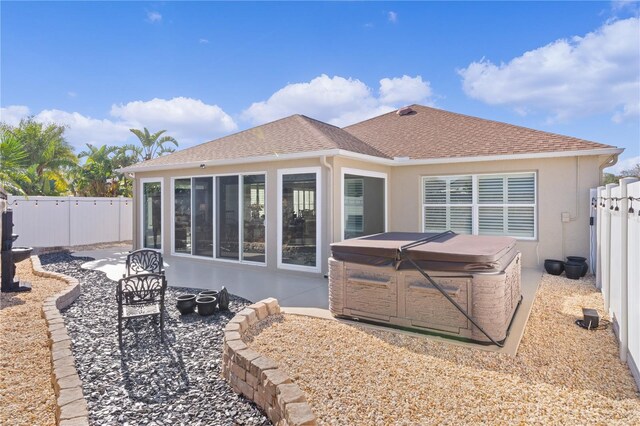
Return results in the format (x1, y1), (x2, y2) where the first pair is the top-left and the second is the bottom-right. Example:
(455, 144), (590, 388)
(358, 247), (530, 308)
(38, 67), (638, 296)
(281, 173), (317, 267)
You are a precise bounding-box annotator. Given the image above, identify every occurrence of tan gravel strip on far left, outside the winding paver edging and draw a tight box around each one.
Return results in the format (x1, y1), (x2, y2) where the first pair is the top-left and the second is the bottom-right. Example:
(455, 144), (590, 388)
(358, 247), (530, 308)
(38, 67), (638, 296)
(0, 260), (67, 426)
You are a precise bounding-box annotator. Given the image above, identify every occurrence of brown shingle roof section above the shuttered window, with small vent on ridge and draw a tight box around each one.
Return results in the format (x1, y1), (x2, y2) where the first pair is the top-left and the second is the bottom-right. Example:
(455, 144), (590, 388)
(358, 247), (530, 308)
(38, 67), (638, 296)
(344, 105), (615, 159)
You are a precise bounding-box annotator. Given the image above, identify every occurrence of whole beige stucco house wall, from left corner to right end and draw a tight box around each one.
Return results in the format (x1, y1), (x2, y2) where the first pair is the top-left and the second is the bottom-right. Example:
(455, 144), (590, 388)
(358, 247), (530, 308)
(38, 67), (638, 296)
(133, 156), (606, 273)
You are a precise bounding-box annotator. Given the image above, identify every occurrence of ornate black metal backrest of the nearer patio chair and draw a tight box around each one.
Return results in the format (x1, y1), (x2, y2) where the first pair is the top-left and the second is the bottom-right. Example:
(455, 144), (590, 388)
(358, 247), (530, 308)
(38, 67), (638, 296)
(117, 274), (167, 306)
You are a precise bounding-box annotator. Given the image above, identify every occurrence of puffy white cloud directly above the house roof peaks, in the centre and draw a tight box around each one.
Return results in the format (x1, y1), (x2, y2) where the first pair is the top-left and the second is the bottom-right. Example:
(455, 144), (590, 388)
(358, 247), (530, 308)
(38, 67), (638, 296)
(242, 74), (431, 126)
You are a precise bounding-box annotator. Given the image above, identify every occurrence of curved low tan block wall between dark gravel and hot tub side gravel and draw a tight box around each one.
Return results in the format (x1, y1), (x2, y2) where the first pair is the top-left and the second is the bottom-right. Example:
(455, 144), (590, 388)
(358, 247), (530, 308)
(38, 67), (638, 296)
(222, 298), (316, 426)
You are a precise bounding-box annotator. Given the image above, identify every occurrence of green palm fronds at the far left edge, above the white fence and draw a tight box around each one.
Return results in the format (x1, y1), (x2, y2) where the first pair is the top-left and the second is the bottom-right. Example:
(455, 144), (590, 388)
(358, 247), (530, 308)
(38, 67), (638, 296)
(0, 128), (30, 195)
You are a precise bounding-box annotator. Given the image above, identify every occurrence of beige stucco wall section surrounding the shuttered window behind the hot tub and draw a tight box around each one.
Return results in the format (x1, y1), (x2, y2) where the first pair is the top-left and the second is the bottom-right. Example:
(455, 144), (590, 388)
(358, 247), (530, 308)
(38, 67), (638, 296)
(389, 156), (606, 267)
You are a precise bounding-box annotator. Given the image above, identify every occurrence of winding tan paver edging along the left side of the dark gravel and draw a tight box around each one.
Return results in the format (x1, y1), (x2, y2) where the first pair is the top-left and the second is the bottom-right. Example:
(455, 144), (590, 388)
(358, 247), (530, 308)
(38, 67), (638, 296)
(31, 256), (89, 426)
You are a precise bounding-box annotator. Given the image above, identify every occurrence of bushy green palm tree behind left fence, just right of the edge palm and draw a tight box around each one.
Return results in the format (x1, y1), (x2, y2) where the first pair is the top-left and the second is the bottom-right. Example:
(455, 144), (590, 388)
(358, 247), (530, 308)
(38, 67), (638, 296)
(9, 117), (78, 195)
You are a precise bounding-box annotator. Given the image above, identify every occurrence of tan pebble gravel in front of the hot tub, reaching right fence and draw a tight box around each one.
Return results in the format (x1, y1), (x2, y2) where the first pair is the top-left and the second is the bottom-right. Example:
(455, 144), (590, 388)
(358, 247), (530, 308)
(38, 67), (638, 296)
(248, 275), (640, 425)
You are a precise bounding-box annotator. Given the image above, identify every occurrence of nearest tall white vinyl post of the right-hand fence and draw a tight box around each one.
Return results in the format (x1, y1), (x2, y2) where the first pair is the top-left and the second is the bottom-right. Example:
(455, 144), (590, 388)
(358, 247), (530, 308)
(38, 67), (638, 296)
(619, 178), (637, 362)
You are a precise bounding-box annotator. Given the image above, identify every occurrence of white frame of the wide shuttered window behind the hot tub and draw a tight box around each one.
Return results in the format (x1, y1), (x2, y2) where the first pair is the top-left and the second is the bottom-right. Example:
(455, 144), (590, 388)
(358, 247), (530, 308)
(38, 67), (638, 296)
(420, 170), (538, 241)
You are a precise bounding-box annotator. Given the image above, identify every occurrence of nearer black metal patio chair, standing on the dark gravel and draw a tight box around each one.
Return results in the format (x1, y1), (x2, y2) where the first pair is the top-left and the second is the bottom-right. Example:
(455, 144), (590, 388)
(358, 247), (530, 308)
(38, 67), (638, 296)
(116, 274), (167, 346)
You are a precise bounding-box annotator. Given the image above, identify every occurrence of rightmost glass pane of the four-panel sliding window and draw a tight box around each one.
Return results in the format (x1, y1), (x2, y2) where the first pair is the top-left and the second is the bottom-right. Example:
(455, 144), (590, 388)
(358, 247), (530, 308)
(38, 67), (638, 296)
(242, 175), (265, 263)
